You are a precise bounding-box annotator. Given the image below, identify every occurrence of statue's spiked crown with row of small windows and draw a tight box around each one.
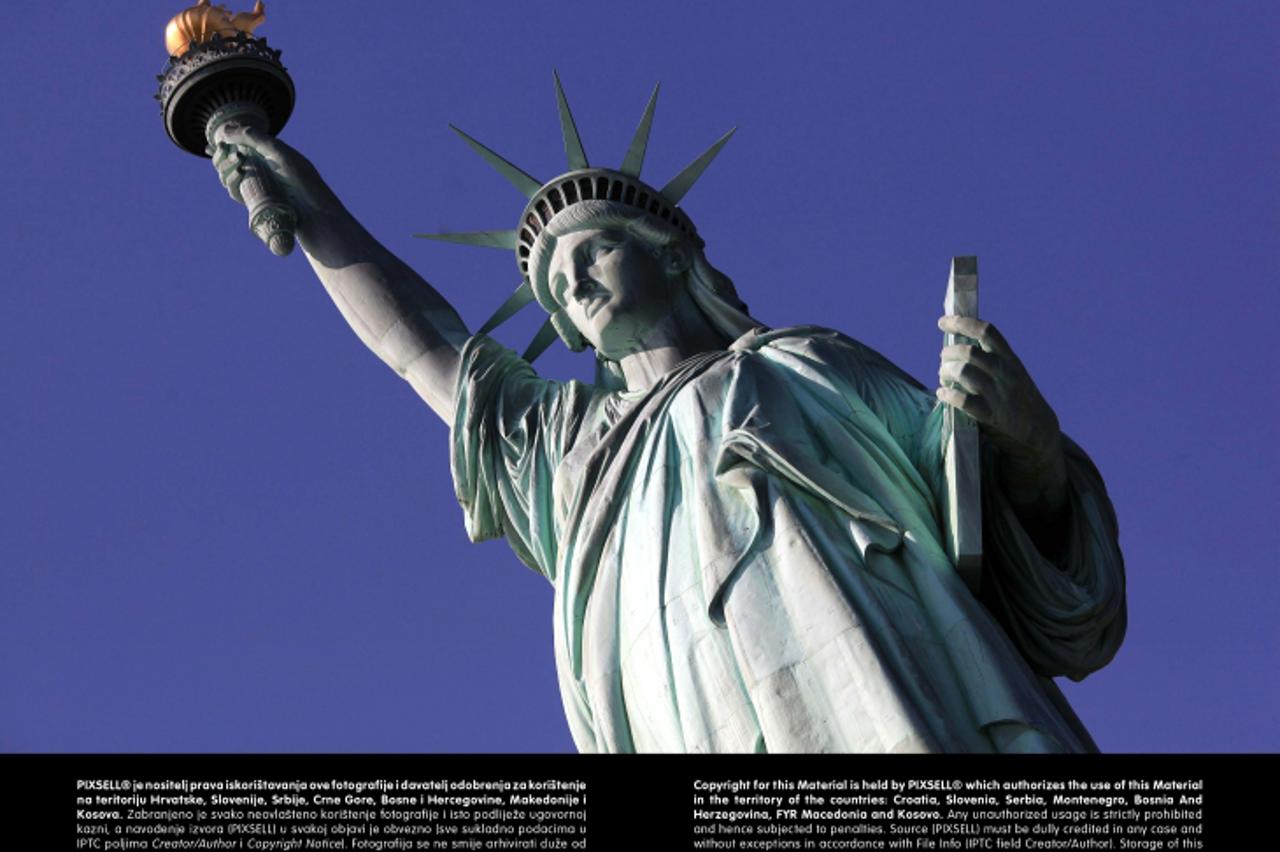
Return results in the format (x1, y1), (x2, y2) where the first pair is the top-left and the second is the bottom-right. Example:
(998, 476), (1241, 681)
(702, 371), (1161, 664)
(415, 74), (736, 361)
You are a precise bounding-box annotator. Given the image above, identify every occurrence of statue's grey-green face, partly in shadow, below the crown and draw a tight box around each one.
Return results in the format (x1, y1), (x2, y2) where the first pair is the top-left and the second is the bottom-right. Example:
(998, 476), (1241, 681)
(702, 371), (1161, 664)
(548, 230), (680, 361)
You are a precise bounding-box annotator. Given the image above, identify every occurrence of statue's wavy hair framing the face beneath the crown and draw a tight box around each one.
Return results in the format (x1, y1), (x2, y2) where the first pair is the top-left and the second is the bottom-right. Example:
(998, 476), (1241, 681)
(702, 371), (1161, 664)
(529, 201), (762, 385)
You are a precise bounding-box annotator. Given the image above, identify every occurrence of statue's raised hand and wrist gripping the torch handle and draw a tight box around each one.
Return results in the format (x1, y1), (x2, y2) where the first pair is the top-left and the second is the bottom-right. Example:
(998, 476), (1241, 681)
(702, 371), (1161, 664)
(212, 123), (339, 220)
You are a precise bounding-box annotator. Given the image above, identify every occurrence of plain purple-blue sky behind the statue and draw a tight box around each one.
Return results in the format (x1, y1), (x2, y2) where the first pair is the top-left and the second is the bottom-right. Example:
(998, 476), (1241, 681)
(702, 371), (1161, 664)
(0, 0), (1280, 751)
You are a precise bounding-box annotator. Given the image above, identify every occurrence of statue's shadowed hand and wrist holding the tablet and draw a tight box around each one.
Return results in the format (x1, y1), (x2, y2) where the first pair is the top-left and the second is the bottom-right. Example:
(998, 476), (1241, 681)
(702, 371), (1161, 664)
(936, 316), (1066, 505)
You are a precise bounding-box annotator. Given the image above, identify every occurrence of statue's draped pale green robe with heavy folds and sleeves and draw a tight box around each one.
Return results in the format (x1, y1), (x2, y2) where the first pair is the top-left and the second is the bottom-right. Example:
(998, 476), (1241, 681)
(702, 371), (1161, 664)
(452, 326), (1125, 752)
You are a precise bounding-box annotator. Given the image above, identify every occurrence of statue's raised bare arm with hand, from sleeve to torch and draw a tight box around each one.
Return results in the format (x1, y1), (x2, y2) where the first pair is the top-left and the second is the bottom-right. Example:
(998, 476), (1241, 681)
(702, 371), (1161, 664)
(214, 125), (468, 422)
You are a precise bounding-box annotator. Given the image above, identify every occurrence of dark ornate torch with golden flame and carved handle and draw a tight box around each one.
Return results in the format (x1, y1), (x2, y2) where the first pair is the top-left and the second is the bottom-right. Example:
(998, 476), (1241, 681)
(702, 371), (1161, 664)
(156, 0), (297, 255)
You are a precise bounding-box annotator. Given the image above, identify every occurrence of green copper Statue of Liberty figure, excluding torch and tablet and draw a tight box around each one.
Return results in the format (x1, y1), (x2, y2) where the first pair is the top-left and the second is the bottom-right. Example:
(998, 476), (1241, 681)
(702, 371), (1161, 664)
(214, 79), (1125, 752)
